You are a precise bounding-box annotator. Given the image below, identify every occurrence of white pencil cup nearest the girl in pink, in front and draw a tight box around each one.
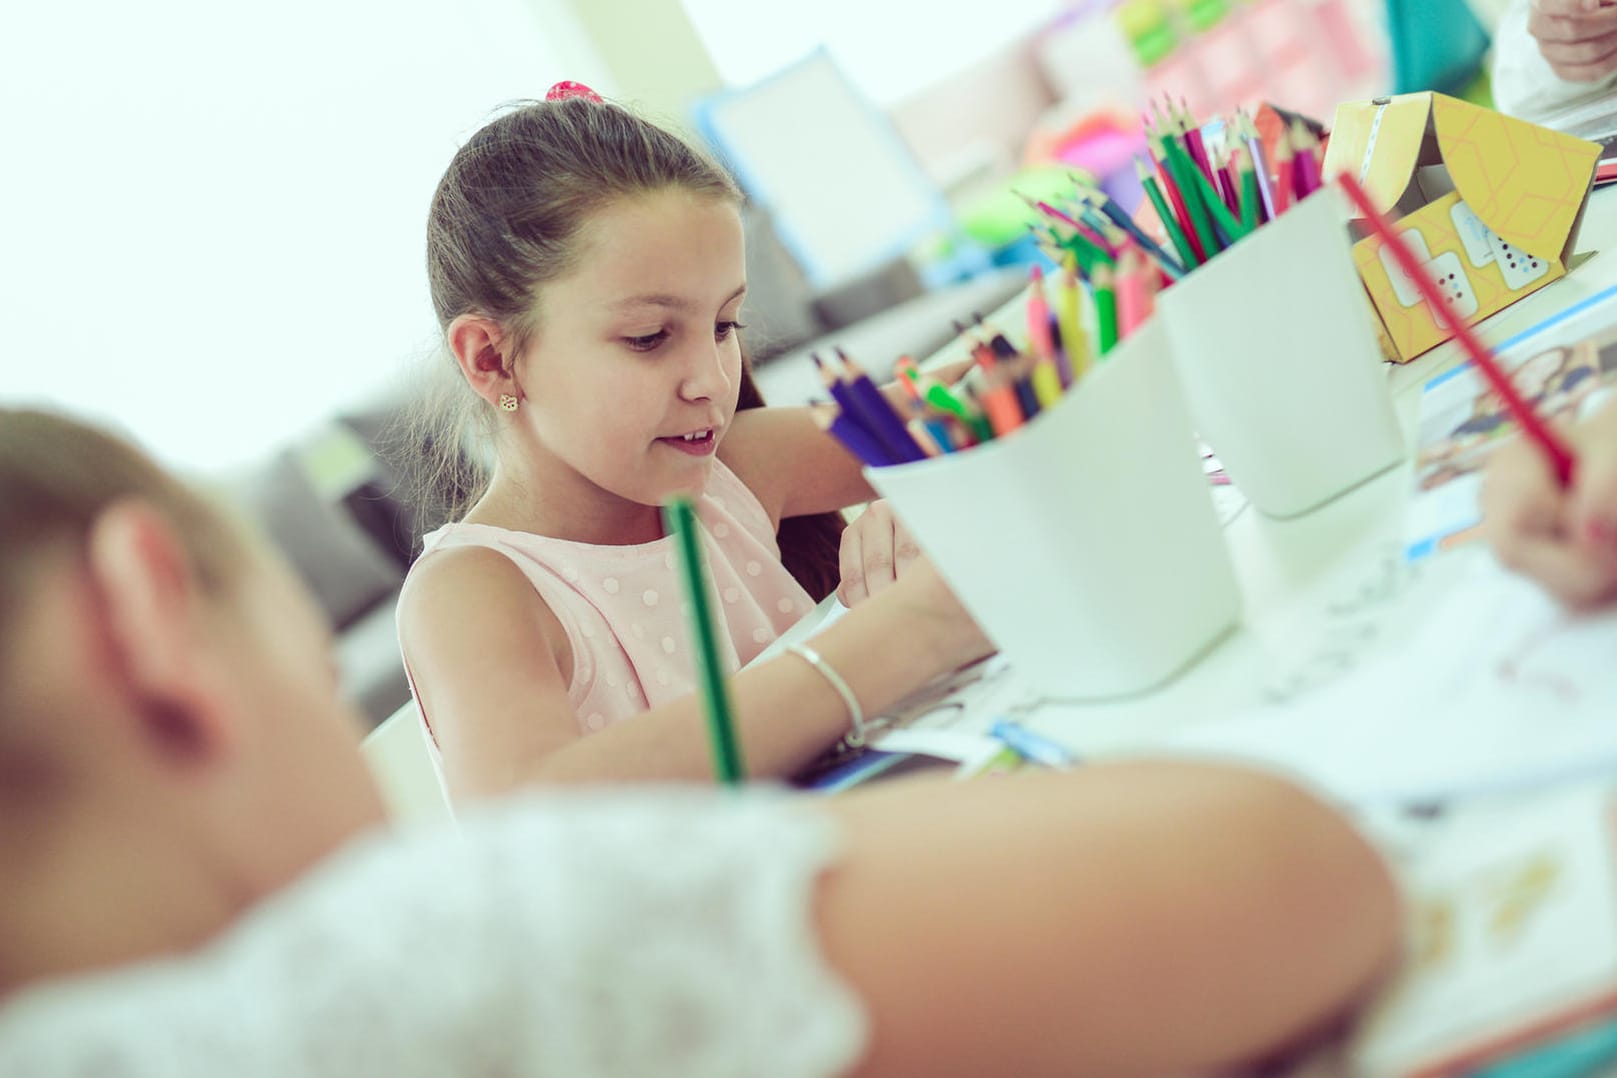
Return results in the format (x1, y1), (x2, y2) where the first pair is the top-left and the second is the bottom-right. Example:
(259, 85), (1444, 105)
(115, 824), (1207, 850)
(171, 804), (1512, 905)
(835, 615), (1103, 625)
(865, 318), (1240, 700)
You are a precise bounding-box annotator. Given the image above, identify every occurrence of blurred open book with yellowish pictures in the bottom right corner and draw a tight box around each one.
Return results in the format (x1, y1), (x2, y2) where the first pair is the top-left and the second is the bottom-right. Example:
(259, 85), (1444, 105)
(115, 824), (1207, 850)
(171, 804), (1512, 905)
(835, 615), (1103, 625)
(1352, 784), (1617, 1078)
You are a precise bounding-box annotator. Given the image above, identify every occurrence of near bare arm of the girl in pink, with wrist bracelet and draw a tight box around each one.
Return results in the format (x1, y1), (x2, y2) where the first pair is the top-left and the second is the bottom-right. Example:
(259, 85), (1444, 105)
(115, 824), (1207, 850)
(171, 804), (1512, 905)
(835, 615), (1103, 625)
(399, 550), (991, 797)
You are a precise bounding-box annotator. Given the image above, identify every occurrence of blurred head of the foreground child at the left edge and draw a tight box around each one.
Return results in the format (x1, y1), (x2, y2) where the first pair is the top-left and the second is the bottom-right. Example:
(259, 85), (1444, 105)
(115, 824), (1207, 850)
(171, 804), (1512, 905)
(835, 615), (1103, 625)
(0, 409), (382, 991)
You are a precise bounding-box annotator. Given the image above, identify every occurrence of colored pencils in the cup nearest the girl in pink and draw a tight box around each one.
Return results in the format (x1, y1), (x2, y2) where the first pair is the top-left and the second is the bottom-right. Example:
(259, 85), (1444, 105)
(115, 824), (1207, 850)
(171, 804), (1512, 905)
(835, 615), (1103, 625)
(813, 258), (1118, 467)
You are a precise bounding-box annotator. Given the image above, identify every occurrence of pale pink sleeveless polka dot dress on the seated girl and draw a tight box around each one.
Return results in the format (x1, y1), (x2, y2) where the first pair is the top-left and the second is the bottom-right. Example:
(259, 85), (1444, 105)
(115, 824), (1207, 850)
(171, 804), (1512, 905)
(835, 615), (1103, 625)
(399, 461), (813, 734)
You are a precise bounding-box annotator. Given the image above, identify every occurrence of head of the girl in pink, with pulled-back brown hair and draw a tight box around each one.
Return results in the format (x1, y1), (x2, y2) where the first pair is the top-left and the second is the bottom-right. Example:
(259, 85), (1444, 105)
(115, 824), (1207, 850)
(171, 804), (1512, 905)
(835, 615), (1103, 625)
(427, 97), (745, 504)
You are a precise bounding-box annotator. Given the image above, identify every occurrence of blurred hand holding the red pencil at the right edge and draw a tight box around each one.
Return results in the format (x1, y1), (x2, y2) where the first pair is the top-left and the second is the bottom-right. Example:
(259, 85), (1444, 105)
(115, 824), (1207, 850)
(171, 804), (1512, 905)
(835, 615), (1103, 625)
(1483, 402), (1617, 606)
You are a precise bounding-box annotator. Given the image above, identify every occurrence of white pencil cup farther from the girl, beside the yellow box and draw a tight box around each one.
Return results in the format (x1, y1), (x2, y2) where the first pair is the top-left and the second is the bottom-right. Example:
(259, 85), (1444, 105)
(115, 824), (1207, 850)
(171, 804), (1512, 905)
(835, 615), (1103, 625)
(1156, 186), (1404, 517)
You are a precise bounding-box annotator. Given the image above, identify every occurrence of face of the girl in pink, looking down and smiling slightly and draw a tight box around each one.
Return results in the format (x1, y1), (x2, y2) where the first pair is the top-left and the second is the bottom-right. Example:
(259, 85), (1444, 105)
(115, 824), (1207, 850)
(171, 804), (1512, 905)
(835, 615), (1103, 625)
(516, 189), (747, 506)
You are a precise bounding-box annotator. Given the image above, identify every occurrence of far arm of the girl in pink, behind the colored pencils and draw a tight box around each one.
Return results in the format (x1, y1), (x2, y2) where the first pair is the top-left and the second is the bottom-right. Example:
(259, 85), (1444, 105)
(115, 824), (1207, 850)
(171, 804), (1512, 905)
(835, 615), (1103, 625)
(718, 360), (972, 527)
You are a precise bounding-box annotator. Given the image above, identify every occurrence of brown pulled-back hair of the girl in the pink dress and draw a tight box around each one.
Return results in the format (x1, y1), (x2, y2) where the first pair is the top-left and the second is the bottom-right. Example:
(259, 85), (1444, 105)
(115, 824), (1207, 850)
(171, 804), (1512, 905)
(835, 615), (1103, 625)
(412, 97), (844, 600)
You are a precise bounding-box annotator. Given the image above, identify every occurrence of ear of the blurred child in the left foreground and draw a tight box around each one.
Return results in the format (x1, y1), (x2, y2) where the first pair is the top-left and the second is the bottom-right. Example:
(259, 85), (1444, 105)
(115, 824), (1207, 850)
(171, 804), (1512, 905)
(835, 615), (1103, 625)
(89, 501), (230, 763)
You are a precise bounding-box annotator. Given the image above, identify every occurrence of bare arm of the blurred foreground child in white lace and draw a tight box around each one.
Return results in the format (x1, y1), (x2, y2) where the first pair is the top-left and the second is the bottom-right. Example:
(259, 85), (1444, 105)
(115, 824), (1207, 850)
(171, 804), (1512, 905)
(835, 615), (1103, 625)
(818, 763), (1399, 1078)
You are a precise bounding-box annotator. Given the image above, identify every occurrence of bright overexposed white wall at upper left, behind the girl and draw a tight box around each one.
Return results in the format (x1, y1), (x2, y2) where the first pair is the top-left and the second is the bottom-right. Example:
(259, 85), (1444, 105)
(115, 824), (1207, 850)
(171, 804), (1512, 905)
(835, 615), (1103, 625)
(0, 0), (614, 472)
